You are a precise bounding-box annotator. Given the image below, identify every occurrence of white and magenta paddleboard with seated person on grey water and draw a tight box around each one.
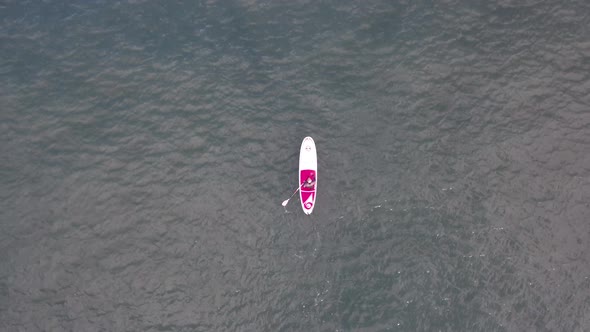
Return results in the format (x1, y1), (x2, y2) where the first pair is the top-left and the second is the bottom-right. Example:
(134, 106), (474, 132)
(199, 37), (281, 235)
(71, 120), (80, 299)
(299, 136), (318, 214)
